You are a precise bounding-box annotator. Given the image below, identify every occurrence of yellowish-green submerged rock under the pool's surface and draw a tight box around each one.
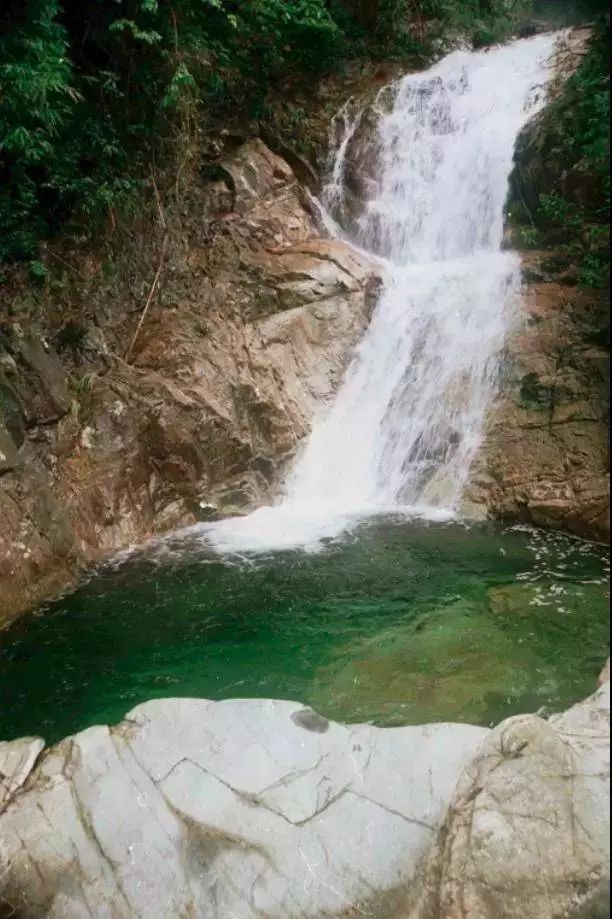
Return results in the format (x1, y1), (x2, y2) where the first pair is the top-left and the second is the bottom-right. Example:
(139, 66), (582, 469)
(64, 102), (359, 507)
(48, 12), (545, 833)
(311, 600), (544, 725)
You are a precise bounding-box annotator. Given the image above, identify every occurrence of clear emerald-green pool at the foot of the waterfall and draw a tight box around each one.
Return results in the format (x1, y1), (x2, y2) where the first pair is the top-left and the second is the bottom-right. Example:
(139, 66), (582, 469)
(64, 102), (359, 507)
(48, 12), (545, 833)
(0, 521), (609, 741)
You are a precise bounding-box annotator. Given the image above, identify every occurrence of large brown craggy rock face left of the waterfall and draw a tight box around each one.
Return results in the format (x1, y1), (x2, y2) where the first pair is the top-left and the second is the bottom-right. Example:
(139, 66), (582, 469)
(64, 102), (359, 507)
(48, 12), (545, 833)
(0, 140), (376, 621)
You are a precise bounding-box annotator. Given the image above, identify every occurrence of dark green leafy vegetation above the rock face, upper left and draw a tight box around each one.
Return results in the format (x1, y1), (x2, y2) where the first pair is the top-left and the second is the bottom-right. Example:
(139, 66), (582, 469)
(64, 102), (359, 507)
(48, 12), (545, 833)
(0, 0), (524, 266)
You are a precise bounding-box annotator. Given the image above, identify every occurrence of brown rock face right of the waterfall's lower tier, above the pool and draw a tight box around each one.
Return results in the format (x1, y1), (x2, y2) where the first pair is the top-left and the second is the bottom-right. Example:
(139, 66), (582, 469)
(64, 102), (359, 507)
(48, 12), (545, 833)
(466, 253), (610, 540)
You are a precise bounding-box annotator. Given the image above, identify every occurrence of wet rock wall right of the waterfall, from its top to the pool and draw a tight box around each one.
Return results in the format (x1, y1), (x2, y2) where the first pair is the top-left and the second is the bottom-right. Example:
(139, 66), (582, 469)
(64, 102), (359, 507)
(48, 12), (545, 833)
(488, 29), (610, 540)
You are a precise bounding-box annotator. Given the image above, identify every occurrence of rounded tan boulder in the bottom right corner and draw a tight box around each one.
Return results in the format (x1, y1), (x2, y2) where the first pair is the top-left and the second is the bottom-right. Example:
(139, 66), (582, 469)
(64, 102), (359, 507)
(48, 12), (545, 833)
(417, 682), (610, 919)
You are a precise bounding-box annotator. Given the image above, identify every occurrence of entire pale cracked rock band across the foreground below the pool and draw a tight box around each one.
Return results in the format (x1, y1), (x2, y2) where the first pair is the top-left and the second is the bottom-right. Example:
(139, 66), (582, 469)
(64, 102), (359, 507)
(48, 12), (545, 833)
(0, 683), (609, 919)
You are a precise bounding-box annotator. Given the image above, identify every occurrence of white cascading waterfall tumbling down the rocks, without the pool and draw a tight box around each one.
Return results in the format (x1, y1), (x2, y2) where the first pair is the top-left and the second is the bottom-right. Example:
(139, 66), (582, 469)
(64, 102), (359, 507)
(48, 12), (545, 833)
(207, 35), (555, 549)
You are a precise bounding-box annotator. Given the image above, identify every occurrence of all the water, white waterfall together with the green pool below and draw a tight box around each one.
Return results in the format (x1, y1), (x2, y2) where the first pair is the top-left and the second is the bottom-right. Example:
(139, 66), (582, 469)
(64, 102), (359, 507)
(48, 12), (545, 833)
(0, 36), (609, 740)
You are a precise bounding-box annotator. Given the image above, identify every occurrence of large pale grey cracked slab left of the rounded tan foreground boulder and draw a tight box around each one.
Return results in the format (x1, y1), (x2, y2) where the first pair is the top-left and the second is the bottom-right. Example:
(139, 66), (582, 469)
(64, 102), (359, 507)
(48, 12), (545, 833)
(0, 700), (486, 919)
